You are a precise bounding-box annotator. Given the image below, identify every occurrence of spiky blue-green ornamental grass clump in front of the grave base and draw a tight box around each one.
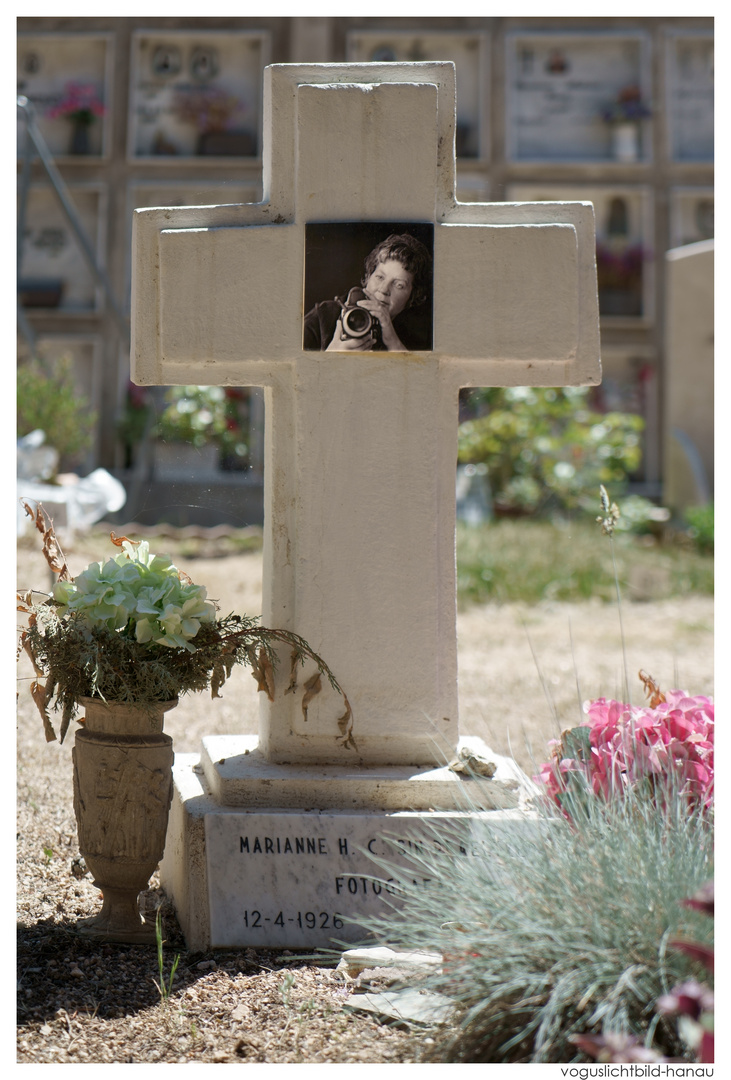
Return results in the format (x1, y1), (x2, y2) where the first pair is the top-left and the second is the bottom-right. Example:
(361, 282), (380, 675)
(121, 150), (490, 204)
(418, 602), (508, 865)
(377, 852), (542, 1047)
(354, 780), (713, 1063)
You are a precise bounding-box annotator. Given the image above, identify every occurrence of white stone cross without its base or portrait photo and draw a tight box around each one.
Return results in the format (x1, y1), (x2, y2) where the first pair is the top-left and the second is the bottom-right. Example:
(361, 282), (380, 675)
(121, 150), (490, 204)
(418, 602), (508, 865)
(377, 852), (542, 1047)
(132, 63), (600, 766)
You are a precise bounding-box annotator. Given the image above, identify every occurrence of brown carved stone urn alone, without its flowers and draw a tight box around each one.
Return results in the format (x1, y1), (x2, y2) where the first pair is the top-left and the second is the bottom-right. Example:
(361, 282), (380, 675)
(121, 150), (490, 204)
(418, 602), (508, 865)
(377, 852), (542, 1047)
(72, 698), (177, 944)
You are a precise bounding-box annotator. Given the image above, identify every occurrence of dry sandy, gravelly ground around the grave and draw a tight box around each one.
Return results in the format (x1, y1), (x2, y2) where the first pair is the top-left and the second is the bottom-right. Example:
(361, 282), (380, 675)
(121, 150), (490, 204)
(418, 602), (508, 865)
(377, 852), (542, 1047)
(17, 530), (714, 1064)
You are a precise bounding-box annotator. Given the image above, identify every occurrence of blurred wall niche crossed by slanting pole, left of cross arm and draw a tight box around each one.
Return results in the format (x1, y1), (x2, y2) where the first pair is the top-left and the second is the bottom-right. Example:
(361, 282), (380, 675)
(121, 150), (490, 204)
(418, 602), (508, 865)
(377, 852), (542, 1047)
(17, 184), (106, 314)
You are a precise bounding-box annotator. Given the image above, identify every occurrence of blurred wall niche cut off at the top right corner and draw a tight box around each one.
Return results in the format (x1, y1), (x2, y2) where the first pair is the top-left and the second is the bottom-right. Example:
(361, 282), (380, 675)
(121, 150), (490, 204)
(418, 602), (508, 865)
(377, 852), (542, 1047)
(665, 32), (714, 162)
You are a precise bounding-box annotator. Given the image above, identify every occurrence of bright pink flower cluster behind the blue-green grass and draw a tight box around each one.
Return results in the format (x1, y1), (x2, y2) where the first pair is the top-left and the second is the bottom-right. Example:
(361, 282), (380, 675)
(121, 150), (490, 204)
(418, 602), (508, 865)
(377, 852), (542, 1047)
(533, 690), (714, 807)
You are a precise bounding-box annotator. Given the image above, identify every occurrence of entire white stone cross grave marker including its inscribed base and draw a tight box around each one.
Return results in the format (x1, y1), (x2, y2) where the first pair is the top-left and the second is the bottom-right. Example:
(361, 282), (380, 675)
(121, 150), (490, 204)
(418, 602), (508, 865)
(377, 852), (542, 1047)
(133, 63), (600, 949)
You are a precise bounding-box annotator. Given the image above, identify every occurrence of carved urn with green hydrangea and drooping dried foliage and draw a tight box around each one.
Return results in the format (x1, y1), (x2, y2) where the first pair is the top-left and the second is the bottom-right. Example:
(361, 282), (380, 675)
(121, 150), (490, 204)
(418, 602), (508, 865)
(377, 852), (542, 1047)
(18, 501), (357, 944)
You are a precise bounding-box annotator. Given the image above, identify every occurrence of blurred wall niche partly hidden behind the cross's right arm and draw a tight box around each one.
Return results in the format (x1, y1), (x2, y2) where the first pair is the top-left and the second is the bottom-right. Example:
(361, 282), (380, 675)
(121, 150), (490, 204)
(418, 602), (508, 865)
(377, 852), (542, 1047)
(506, 184), (654, 325)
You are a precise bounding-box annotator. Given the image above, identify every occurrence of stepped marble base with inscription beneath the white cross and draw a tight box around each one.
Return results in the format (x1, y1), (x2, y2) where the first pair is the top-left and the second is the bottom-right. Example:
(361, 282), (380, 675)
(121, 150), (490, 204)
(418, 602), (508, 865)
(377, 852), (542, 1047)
(160, 735), (536, 951)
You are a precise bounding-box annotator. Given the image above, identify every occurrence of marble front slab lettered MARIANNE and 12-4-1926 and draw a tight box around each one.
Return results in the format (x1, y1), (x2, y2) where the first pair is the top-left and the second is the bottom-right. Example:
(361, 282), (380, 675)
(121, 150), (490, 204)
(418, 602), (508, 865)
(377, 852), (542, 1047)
(204, 809), (525, 948)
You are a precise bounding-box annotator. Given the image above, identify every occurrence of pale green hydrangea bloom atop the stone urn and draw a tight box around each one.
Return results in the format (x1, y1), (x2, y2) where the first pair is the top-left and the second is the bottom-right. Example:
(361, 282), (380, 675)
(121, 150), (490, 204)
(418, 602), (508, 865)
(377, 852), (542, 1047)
(53, 540), (216, 652)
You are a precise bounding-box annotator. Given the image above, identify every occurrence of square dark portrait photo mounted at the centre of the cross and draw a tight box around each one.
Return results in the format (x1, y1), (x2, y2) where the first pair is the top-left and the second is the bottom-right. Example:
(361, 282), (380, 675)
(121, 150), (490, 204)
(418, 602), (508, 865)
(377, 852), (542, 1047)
(302, 221), (434, 353)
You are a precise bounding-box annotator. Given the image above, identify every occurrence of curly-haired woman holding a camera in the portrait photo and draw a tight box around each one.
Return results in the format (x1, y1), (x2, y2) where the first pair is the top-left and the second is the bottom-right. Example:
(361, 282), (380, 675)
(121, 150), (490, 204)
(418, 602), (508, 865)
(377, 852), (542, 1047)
(303, 232), (432, 352)
